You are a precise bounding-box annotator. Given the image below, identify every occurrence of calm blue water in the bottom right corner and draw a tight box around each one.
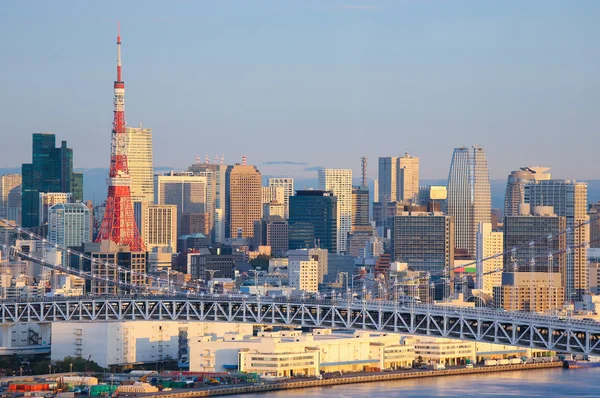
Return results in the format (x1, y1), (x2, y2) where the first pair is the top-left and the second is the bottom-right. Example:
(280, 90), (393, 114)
(237, 368), (600, 398)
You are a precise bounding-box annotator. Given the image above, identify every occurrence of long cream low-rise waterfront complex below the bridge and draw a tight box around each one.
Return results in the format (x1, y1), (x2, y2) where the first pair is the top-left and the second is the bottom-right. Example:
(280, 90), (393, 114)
(189, 329), (414, 378)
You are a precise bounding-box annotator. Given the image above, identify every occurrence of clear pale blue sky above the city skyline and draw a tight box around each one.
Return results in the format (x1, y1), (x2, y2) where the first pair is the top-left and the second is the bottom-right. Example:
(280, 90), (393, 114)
(0, 0), (600, 179)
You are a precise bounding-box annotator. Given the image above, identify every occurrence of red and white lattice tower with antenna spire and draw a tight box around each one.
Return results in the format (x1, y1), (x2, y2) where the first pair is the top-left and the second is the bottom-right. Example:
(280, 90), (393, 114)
(96, 27), (146, 252)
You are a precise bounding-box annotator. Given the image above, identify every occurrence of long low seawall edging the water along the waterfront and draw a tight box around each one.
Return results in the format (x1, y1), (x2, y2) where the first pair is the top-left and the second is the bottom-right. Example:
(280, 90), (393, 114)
(154, 361), (562, 398)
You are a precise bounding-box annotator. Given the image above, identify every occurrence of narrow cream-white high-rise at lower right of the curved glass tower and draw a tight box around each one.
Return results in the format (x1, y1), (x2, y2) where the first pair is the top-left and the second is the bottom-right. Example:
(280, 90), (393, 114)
(476, 222), (504, 294)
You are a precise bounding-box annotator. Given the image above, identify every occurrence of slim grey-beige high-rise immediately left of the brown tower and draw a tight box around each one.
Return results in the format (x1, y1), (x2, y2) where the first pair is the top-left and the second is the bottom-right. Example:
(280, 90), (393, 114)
(188, 159), (227, 243)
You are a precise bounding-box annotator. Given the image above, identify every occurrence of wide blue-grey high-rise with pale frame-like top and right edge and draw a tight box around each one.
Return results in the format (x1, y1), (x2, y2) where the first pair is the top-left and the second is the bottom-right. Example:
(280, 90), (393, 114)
(154, 172), (212, 236)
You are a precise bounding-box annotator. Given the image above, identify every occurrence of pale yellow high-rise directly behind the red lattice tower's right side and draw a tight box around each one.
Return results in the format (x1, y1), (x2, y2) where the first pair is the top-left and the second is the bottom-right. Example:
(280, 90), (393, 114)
(125, 125), (154, 203)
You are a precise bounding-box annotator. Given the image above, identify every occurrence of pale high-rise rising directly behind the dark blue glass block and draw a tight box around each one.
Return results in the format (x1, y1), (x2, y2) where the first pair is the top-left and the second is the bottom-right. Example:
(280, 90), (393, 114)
(319, 169), (352, 253)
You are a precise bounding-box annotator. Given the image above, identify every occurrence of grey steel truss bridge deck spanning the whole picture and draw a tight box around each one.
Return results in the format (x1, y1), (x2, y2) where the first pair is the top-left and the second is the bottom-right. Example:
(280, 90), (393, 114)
(0, 295), (600, 355)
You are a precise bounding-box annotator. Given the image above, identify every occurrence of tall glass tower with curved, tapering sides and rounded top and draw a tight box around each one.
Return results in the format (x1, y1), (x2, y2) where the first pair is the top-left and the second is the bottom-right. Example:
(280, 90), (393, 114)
(448, 147), (492, 255)
